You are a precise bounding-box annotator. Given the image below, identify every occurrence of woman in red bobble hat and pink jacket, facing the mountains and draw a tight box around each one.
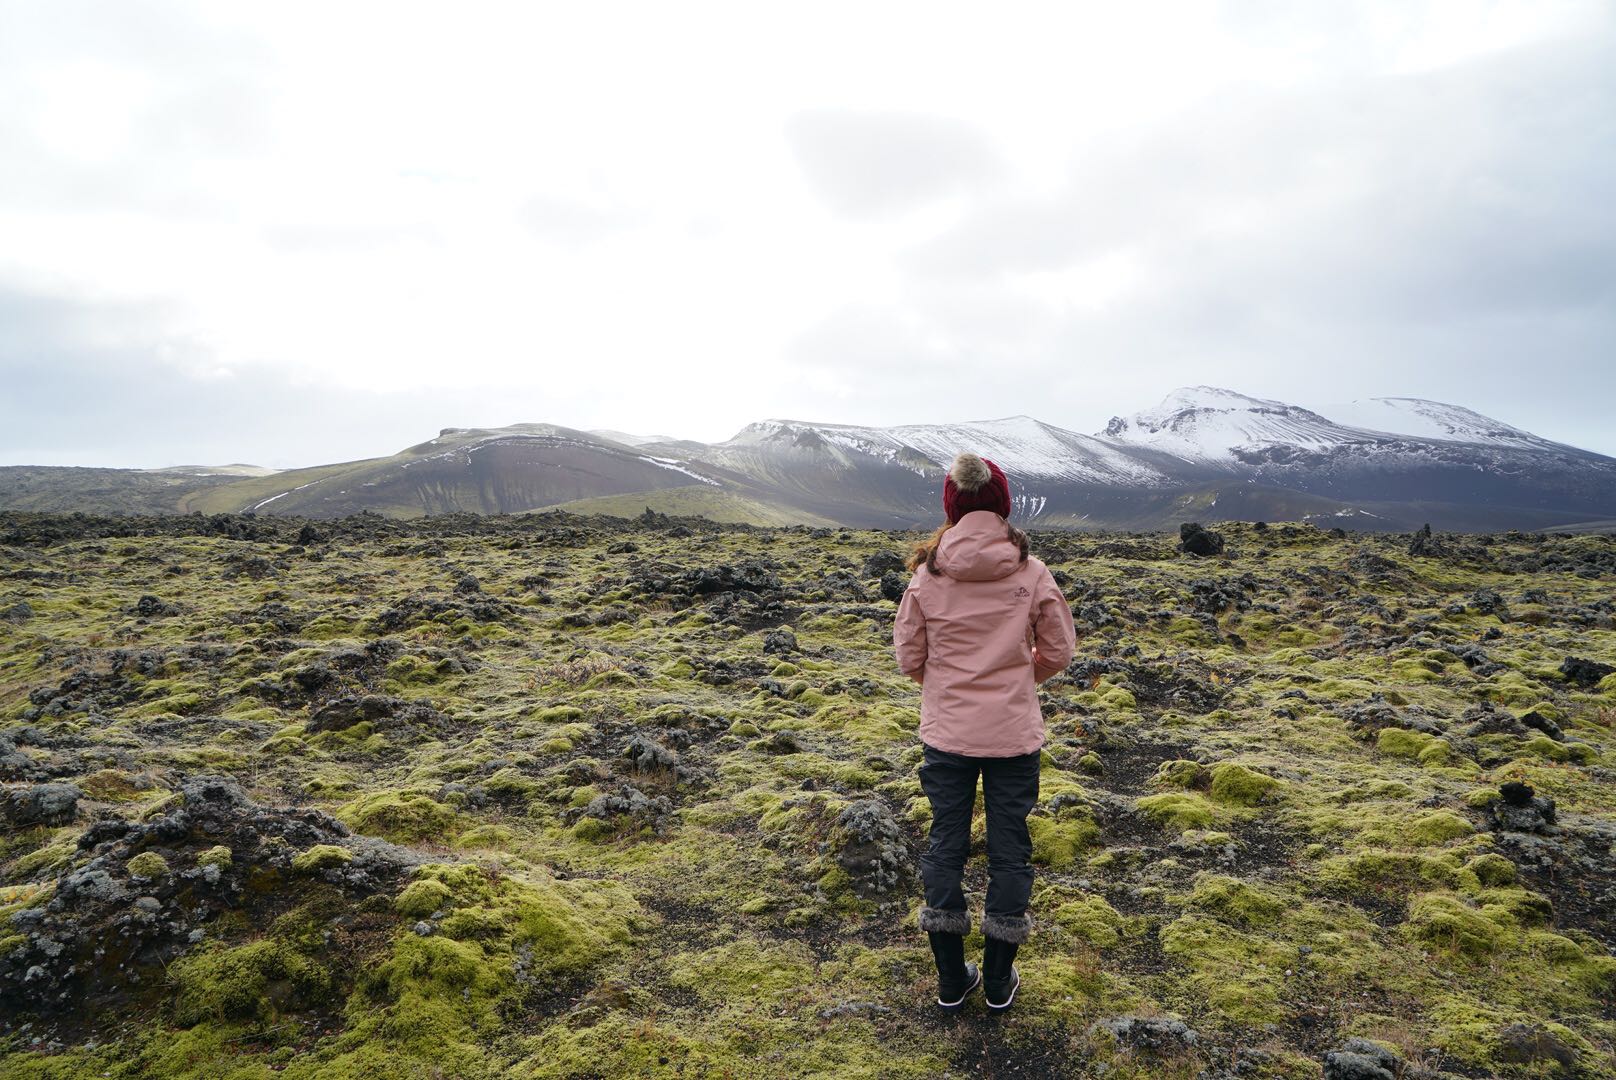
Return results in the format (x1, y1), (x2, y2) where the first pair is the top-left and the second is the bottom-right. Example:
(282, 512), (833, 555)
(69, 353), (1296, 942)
(892, 454), (1076, 1010)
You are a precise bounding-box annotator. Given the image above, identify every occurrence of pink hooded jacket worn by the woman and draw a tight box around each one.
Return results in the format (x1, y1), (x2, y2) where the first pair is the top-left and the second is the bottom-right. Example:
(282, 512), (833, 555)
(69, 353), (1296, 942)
(892, 509), (1076, 758)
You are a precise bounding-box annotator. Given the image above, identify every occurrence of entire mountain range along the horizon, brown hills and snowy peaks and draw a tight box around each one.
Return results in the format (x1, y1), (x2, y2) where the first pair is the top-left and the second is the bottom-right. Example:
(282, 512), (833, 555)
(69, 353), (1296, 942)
(9, 386), (1616, 530)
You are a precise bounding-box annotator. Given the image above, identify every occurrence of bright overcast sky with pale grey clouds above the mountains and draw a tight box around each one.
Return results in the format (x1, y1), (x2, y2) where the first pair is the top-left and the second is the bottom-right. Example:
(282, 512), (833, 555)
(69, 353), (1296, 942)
(0, 0), (1616, 467)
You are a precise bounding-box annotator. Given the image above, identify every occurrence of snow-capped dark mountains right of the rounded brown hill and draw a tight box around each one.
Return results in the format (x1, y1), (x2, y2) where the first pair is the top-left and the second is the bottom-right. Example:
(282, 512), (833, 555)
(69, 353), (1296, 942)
(680, 386), (1616, 527)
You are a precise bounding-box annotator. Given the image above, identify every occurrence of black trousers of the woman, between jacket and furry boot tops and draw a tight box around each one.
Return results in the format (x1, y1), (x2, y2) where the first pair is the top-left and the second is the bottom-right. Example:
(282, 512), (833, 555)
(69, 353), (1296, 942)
(920, 744), (1041, 918)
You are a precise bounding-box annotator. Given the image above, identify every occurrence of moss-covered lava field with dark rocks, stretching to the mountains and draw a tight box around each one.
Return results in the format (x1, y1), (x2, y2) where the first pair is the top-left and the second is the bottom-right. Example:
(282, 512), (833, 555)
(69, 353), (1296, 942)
(0, 517), (1616, 1080)
